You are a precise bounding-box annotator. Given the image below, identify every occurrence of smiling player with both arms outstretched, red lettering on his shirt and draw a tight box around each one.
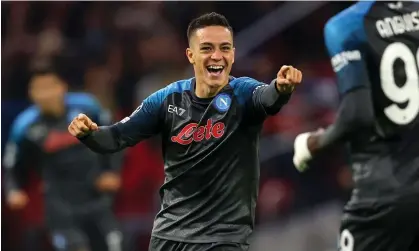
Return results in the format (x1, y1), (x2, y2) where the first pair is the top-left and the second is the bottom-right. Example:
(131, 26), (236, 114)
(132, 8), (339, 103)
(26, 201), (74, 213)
(69, 13), (302, 251)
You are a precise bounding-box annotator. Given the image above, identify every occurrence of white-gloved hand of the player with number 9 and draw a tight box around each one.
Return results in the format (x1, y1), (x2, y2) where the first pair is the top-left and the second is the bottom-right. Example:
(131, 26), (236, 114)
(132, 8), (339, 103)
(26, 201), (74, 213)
(293, 128), (324, 172)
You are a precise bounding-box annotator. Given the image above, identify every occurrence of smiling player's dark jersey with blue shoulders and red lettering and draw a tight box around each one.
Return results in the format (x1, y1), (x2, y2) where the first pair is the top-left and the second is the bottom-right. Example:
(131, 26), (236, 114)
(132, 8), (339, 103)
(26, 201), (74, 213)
(110, 77), (290, 243)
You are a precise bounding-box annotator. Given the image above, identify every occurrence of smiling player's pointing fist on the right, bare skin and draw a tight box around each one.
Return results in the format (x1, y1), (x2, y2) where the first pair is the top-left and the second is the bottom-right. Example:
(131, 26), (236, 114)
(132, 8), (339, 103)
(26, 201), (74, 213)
(276, 65), (303, 92)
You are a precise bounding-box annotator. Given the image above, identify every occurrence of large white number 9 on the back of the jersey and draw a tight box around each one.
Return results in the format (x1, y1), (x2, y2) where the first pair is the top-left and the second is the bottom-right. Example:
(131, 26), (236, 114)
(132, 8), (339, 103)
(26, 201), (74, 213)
(380, 42), (419, 125)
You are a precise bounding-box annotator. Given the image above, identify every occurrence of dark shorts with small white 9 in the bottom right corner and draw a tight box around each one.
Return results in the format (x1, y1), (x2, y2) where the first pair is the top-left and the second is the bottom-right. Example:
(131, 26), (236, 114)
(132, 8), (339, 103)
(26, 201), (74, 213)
(339, 198), (419, 251)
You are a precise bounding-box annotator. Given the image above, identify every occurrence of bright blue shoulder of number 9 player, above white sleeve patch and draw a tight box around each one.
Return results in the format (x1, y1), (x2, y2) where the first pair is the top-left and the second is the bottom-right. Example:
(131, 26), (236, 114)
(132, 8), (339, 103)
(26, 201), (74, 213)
(324, 2), (374, 51)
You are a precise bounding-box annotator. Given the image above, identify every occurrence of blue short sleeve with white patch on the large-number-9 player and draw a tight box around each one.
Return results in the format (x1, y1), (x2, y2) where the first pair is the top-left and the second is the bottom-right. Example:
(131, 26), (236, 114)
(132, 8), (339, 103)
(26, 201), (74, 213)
(324, 2), (373, 95)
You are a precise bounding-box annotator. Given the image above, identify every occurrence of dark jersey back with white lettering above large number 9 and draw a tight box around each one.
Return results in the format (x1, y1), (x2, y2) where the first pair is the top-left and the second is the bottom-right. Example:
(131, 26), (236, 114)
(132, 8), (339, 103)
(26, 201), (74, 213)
(364, 2), (419, 141)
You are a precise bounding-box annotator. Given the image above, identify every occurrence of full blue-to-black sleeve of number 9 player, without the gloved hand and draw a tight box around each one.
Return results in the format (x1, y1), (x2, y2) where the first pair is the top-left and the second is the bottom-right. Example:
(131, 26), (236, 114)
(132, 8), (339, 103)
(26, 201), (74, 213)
(318, 2), (374, 149)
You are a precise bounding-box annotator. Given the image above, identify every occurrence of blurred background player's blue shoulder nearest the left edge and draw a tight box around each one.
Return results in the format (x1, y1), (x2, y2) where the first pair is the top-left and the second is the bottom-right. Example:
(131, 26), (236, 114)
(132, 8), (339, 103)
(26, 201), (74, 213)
(10, 105), (40, 142)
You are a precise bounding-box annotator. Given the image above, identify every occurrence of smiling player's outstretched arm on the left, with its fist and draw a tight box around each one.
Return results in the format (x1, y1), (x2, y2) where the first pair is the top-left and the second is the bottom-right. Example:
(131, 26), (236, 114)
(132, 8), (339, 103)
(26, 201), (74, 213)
(68, 92), (162, 153)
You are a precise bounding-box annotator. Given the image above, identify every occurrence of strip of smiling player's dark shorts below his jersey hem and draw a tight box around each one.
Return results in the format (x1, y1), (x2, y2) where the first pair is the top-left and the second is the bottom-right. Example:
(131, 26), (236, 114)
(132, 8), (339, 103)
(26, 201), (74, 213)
(148, 237), (249, 251)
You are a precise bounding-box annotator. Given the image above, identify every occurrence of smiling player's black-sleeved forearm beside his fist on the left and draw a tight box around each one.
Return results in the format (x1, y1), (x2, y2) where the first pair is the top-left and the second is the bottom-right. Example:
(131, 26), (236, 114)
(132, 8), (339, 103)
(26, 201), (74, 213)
(79, 126), (125, 153)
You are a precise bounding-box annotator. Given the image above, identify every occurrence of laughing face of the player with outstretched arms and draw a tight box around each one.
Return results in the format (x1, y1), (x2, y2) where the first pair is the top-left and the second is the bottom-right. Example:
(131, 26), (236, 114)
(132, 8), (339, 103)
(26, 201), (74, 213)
(186, 26), (234, 88)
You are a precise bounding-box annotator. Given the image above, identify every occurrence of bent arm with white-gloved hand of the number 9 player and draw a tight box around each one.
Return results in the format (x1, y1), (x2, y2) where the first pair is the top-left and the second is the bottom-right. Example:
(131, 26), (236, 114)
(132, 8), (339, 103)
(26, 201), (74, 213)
(294, 16), (374, 170)
